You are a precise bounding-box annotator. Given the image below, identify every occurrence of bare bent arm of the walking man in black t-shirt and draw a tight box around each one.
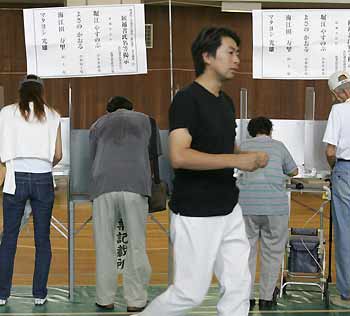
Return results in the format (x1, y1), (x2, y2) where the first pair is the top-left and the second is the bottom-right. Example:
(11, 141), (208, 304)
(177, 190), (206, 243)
(169, 128), (268, 171)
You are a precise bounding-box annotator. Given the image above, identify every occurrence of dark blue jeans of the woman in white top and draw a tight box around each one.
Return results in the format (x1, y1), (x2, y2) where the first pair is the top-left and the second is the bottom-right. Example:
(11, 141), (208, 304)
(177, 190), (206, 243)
(0, 172), (54, 299)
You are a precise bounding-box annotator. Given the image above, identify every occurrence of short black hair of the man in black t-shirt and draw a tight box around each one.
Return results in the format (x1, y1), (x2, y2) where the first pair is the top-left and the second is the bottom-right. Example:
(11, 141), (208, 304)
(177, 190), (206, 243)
(191, 27), (241, 77)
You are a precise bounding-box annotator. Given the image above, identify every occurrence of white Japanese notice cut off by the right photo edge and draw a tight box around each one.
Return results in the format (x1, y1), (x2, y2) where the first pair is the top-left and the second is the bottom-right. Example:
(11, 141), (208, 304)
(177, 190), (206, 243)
(253, 9), (350, 79)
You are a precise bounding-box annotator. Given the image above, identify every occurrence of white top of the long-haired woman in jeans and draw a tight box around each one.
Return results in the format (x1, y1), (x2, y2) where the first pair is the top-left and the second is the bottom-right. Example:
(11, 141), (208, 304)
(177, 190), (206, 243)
(0, 103), (60, 194)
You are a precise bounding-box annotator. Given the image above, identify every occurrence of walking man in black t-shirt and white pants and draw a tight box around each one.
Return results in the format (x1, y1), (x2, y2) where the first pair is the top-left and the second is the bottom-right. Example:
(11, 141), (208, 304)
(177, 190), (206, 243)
(134, 27), (268, 316)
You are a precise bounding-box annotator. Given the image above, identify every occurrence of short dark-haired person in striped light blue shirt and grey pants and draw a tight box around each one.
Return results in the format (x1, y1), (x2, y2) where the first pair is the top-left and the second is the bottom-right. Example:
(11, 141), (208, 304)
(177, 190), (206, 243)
(239, 117), (298, 310)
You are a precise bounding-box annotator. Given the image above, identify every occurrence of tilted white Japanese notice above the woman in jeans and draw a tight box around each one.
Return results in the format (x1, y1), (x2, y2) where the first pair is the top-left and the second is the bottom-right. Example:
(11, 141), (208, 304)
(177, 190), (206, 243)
(23, 4), (147, 78)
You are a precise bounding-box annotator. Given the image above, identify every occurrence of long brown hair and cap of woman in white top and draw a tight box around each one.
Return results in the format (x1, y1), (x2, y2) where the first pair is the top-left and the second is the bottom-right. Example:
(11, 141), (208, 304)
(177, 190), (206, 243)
(18, 75), (51, 121)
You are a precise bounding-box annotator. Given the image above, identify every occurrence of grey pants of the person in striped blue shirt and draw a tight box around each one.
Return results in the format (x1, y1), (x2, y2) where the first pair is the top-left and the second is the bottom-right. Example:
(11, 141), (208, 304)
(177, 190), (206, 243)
(243, 215), (289, 301)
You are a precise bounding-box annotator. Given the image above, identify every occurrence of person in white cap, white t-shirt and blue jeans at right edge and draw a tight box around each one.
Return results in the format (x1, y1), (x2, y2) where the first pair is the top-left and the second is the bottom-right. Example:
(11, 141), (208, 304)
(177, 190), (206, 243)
(323, 71), (350, 308)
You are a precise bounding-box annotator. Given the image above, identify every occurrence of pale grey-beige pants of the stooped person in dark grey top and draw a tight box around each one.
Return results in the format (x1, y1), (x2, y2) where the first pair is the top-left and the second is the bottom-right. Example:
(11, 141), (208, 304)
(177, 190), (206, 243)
(93, 192), (151, 307)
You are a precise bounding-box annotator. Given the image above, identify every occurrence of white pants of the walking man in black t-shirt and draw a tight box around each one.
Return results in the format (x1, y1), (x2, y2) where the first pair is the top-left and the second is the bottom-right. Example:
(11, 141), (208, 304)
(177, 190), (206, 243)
(138, 205), (250, 316)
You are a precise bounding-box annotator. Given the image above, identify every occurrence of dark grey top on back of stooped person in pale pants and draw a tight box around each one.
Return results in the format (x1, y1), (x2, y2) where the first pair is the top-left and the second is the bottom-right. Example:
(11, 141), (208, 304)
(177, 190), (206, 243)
(89, 109), (152, 199)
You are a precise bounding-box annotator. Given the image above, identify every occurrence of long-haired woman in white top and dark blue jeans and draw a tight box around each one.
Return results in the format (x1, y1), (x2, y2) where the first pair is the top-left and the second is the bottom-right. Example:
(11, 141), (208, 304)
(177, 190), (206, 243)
(0, 75), (62, 305)
